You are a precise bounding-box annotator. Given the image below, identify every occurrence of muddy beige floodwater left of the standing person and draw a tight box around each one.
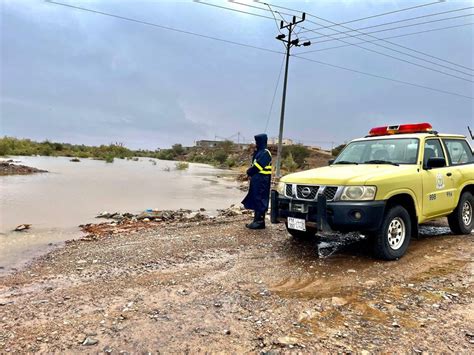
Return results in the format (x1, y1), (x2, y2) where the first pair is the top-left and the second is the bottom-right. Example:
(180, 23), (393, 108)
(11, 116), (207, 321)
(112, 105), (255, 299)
(0, 157), (244, 273)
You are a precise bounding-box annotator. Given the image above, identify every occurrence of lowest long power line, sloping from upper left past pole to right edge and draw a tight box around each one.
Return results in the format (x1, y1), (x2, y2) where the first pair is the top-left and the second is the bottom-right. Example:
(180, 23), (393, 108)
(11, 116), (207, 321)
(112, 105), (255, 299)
(46, 0), (474, 100)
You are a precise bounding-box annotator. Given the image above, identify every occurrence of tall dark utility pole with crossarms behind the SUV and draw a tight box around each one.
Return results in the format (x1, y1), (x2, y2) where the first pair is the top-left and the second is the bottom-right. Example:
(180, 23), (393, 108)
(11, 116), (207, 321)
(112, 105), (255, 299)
(275, 12), (311, 178)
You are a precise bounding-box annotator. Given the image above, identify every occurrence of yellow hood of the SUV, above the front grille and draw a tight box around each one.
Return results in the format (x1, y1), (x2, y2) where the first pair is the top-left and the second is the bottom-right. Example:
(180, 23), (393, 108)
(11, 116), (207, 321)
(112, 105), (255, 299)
(281, 164), (418, 185)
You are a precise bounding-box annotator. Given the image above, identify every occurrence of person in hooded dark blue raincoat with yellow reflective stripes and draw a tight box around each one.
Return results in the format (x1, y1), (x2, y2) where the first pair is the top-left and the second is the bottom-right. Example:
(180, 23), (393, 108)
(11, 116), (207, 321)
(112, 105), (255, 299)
(242, 134), (272, 229)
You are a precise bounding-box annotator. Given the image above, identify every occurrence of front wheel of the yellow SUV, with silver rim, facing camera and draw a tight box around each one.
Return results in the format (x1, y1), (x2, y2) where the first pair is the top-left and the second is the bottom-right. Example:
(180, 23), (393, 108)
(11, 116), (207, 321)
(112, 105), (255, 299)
(371, 206), (411, 260)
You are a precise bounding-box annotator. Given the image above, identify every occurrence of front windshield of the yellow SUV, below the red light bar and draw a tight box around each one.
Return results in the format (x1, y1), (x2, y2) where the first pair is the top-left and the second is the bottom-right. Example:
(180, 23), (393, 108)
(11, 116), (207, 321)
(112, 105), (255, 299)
(334, 138), (419, 165)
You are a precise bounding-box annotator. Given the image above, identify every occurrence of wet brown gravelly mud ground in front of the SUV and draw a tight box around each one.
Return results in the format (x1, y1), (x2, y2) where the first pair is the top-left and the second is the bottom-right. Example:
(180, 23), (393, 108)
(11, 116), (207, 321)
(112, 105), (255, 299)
(0, 216), (474, 353)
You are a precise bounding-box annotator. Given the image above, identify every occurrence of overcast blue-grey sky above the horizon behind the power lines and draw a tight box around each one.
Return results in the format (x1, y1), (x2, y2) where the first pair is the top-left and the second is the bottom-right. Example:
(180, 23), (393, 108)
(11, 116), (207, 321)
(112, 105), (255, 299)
(0, 0), (474, 149)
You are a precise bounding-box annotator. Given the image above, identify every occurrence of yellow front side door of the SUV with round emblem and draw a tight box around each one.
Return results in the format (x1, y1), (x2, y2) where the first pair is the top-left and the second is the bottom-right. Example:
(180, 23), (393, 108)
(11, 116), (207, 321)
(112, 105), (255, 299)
(422, 138), (455, 218)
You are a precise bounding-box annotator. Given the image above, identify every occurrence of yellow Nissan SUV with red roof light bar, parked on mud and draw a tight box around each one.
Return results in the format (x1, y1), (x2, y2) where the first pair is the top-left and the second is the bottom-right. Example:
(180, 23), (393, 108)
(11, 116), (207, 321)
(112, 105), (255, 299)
(271, 123), (474, 260)
